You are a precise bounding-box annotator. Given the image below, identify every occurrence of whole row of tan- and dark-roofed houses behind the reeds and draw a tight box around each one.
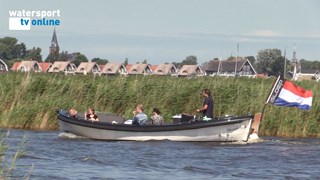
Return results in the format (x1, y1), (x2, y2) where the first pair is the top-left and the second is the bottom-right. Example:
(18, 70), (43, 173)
(0, 59), (257, 77)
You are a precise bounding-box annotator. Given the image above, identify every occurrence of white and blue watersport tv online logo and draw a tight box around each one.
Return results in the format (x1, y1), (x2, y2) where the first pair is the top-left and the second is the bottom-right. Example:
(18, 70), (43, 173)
(9, 9), (61, 30)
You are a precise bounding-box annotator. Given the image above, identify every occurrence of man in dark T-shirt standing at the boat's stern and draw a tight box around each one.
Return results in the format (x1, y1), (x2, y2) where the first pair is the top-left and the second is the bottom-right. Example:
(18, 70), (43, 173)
(197, 89), (214, 120)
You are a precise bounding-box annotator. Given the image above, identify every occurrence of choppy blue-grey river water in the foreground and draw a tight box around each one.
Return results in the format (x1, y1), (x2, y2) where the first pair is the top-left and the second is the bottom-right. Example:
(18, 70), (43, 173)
(2, 129), (320, 180)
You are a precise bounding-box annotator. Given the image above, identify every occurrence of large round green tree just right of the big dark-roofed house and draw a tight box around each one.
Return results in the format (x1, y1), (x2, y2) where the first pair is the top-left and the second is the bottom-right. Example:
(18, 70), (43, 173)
(257, 49), (282, 75)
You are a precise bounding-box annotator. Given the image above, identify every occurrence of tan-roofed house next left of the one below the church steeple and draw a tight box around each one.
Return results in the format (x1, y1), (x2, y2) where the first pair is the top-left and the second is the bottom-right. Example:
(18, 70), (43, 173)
(11, 60), (42, 72)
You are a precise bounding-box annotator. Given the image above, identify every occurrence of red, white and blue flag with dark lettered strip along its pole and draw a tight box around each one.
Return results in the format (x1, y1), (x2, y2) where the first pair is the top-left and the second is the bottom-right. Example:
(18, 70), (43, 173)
(266, 76), (312, 110)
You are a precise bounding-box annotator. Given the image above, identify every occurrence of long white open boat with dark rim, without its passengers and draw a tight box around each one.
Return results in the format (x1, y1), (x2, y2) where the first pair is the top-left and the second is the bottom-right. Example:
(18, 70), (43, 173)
(58, 110), (261, 142)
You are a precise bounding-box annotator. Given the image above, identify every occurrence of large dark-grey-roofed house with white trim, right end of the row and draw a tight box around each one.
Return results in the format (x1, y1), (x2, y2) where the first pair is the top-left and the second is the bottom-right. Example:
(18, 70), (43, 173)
(203, 58), (257, 77)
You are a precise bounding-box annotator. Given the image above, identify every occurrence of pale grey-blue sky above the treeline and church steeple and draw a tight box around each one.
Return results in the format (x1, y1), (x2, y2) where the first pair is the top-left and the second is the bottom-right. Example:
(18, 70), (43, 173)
(0, 0), (320, 65)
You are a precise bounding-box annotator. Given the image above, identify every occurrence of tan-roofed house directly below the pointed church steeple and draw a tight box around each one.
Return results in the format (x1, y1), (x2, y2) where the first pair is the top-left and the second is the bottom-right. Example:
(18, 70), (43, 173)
(48, 61), (77, 75)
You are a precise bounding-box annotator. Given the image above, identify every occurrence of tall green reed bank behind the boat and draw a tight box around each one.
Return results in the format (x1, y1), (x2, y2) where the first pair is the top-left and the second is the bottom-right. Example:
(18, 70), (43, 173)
(0, 72), (320, 137)
